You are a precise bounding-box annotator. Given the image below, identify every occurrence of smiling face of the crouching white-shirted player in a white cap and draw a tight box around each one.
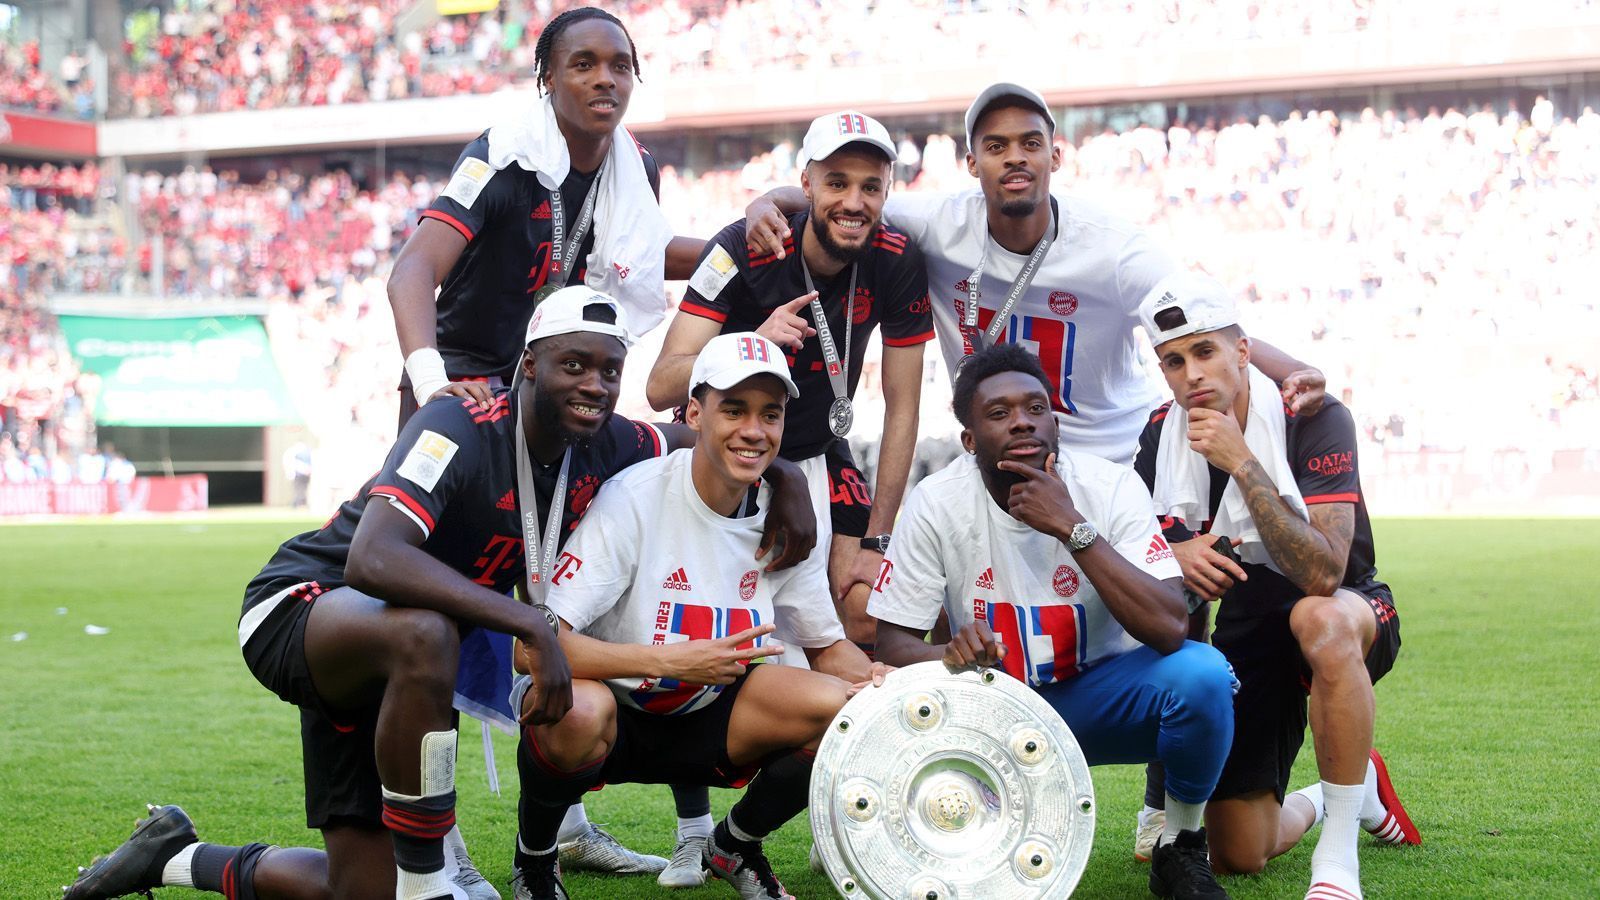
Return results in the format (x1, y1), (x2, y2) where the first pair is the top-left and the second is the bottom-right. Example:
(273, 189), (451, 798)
(683, 375), (789, 490)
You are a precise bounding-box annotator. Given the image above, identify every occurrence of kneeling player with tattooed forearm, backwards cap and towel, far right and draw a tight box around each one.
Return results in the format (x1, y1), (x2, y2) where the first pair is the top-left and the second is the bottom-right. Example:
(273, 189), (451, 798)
(1136, 274), (1421, 900)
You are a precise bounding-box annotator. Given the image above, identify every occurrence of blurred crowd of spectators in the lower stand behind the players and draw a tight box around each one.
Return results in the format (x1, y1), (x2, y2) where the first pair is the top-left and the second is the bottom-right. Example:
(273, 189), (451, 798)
(0, 98), (1600, 506)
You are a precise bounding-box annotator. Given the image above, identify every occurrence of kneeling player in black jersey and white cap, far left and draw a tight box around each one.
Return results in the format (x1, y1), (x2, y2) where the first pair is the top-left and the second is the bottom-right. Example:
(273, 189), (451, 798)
(67, 288), (810, 900)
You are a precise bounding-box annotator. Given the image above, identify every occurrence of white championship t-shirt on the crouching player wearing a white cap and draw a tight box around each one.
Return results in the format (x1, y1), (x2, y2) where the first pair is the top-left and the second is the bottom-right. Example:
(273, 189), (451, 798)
(546, 448), (845, 714)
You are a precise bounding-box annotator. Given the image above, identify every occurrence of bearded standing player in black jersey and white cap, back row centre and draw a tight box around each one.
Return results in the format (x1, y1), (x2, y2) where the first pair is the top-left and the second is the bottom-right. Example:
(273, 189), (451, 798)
(646, 110), (933, 666)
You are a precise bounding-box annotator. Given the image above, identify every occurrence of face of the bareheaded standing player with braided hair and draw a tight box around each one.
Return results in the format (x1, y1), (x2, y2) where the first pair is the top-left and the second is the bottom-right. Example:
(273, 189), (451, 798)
(544, 19), (635, 139)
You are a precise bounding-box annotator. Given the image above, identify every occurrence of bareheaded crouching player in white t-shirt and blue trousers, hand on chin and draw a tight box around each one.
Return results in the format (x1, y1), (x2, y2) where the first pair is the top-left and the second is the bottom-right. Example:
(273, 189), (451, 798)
(867, 344), (1235, 897)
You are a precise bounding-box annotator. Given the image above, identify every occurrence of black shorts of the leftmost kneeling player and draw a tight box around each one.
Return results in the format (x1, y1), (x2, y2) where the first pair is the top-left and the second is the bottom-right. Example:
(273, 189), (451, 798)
(245, 581), (384, 830)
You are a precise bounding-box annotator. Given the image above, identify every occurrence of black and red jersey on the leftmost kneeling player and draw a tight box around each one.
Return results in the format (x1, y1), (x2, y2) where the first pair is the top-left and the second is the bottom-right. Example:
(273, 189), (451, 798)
(245, 391), (666, 612)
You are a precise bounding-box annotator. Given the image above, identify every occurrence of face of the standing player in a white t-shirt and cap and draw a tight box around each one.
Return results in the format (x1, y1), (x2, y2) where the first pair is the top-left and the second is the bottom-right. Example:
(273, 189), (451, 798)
(966, 106), (1061, 218)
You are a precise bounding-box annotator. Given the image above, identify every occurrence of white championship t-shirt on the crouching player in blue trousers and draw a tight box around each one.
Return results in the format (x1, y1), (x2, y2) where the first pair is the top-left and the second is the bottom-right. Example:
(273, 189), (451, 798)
(867, 450), (1182, 687)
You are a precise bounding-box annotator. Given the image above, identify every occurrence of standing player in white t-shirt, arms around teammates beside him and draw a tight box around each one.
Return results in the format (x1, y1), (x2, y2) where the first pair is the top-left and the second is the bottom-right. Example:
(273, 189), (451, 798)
(746, 83), (1323, 464)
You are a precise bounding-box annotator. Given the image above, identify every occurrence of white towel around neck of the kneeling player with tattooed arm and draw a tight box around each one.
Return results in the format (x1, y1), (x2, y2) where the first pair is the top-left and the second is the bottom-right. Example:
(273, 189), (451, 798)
(1154, 368), (1310, 572)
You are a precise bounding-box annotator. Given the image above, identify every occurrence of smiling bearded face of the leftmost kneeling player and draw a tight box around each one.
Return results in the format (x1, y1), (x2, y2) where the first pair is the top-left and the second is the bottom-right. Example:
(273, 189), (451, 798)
(523, 331), (627, 444)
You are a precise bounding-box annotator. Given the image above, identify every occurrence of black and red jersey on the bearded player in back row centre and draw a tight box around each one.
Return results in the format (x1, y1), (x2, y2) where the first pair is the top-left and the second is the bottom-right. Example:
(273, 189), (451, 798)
(678, 213), (933, 460)
